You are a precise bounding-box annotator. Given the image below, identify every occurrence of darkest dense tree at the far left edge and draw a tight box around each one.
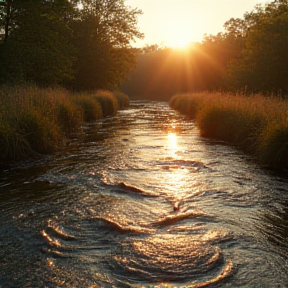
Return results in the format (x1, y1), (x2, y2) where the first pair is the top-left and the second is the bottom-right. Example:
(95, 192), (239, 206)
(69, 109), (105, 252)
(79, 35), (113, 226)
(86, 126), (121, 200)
(0, 0), (75, 85)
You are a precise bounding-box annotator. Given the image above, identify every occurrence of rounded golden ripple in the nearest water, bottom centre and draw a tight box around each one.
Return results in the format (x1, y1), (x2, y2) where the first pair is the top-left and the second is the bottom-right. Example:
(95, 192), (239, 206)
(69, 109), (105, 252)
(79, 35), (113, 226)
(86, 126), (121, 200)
(114, 231), (232, 287)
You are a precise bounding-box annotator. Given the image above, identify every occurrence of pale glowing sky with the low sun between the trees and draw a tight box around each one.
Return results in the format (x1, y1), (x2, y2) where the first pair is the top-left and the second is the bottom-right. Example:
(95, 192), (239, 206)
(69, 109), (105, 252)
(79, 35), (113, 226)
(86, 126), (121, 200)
(125, 0), (272, 47)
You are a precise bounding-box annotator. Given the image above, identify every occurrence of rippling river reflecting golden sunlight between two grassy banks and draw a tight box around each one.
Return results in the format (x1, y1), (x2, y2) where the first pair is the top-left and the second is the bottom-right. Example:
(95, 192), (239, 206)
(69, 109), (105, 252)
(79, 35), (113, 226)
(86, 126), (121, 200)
(0, 101), (288, 288)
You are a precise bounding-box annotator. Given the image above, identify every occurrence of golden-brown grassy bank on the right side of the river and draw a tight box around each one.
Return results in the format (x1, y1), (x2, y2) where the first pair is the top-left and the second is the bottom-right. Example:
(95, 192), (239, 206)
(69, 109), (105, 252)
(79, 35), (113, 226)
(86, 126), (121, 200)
(169, 93), (288, 169)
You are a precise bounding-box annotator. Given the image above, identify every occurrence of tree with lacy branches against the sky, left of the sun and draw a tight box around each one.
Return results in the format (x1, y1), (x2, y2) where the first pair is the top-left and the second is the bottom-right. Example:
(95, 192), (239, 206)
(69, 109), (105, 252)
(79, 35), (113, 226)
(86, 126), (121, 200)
(72, 0), (143, 90)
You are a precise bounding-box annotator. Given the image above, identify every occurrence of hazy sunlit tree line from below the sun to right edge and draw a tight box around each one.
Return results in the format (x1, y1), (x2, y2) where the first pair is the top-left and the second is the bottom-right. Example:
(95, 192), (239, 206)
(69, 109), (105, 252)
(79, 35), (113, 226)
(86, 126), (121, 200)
(122, 0), (288, 99)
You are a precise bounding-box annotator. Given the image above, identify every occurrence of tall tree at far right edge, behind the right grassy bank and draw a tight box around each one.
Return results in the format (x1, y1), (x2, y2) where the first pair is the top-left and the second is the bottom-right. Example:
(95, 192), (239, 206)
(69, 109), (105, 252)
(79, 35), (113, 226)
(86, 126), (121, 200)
(226, 0), (288, 93)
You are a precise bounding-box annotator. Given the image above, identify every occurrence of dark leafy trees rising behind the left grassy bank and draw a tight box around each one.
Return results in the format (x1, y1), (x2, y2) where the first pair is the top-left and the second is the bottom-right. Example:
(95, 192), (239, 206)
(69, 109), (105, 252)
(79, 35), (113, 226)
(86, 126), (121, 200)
(0, 0), (143, 90)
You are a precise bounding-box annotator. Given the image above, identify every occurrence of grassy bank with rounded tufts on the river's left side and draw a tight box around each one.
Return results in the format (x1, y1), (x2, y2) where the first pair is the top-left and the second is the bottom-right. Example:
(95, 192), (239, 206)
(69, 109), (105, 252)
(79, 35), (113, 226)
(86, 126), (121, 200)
(0, 86), (129, 161)
